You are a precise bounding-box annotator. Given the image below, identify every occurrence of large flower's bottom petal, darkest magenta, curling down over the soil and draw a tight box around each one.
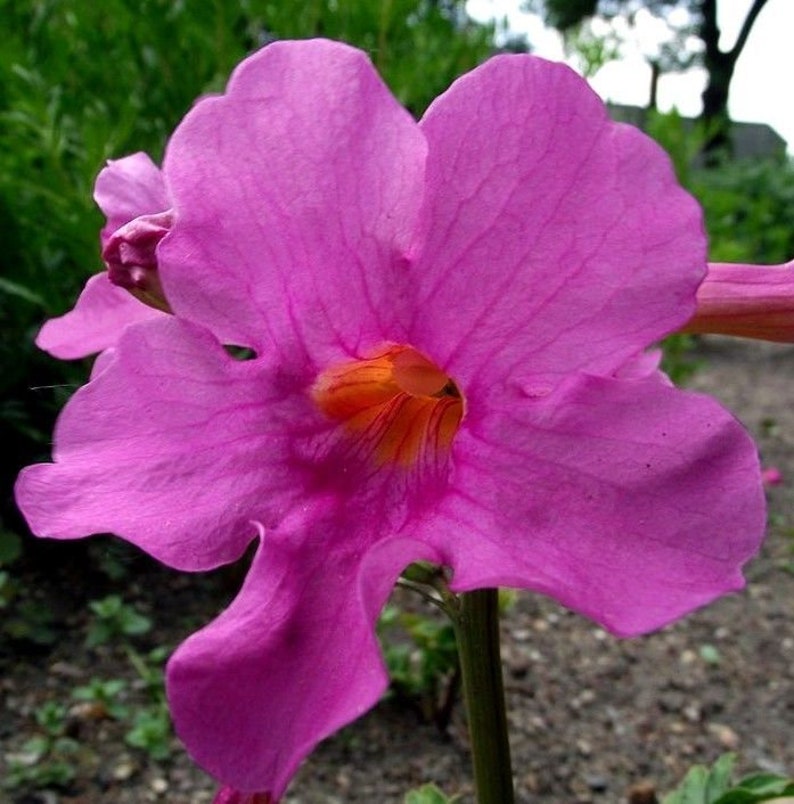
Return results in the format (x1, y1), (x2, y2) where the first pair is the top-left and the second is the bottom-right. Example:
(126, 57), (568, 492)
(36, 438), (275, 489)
(167, 528), (438, 799)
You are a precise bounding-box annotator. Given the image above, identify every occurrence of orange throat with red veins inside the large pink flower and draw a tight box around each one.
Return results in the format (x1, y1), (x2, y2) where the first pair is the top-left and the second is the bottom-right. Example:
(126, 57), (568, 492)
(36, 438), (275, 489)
(312, 346), (463, 467)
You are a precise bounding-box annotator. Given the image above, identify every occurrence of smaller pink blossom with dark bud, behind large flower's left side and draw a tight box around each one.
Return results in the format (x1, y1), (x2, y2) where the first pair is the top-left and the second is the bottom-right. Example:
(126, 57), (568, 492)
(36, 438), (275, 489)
(36, 153), (171, 360)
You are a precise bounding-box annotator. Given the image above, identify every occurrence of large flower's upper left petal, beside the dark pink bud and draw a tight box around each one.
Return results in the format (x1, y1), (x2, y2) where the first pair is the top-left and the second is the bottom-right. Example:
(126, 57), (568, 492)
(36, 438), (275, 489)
(159, 40), (426, 360)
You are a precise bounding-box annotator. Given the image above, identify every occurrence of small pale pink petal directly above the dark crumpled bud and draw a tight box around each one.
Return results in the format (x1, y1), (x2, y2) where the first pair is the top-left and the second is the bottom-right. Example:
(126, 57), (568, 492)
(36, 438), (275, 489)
(94, 152), (171, 246)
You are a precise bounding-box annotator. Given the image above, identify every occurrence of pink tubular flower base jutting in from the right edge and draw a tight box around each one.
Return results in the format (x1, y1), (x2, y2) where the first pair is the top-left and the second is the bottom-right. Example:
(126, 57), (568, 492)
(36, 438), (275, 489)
(684, 262), (794, 343)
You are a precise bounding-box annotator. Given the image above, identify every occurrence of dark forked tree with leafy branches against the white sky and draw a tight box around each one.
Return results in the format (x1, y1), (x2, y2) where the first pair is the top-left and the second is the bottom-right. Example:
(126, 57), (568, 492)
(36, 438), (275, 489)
(527, 0), (767, 151)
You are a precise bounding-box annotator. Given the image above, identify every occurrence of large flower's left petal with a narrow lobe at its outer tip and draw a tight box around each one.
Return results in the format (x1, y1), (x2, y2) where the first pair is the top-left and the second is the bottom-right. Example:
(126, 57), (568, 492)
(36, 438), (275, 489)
(16, 315), (311, 570)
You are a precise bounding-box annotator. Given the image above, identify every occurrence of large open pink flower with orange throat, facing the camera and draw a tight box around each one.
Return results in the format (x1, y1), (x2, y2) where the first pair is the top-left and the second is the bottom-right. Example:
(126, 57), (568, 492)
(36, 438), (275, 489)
(17, 41), (764, 799)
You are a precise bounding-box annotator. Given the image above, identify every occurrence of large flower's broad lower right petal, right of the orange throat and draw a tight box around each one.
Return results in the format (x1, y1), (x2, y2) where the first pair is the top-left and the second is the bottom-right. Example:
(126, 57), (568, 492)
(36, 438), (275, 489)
(425, 377), (765, 635)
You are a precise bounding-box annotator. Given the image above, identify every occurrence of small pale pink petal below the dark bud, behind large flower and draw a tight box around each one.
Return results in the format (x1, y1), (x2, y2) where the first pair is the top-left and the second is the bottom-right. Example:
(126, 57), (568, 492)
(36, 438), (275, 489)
(36, 273), (165, 360)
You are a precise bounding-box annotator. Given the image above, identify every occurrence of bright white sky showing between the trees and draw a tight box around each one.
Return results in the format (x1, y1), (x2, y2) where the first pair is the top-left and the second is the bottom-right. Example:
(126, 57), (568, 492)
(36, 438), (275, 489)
(467, 0), (794, 154)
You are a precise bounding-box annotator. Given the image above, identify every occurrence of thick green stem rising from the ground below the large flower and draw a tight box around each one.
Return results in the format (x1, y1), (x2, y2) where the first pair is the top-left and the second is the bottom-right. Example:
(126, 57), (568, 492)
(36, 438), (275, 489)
(455, 589), (514, 804)
